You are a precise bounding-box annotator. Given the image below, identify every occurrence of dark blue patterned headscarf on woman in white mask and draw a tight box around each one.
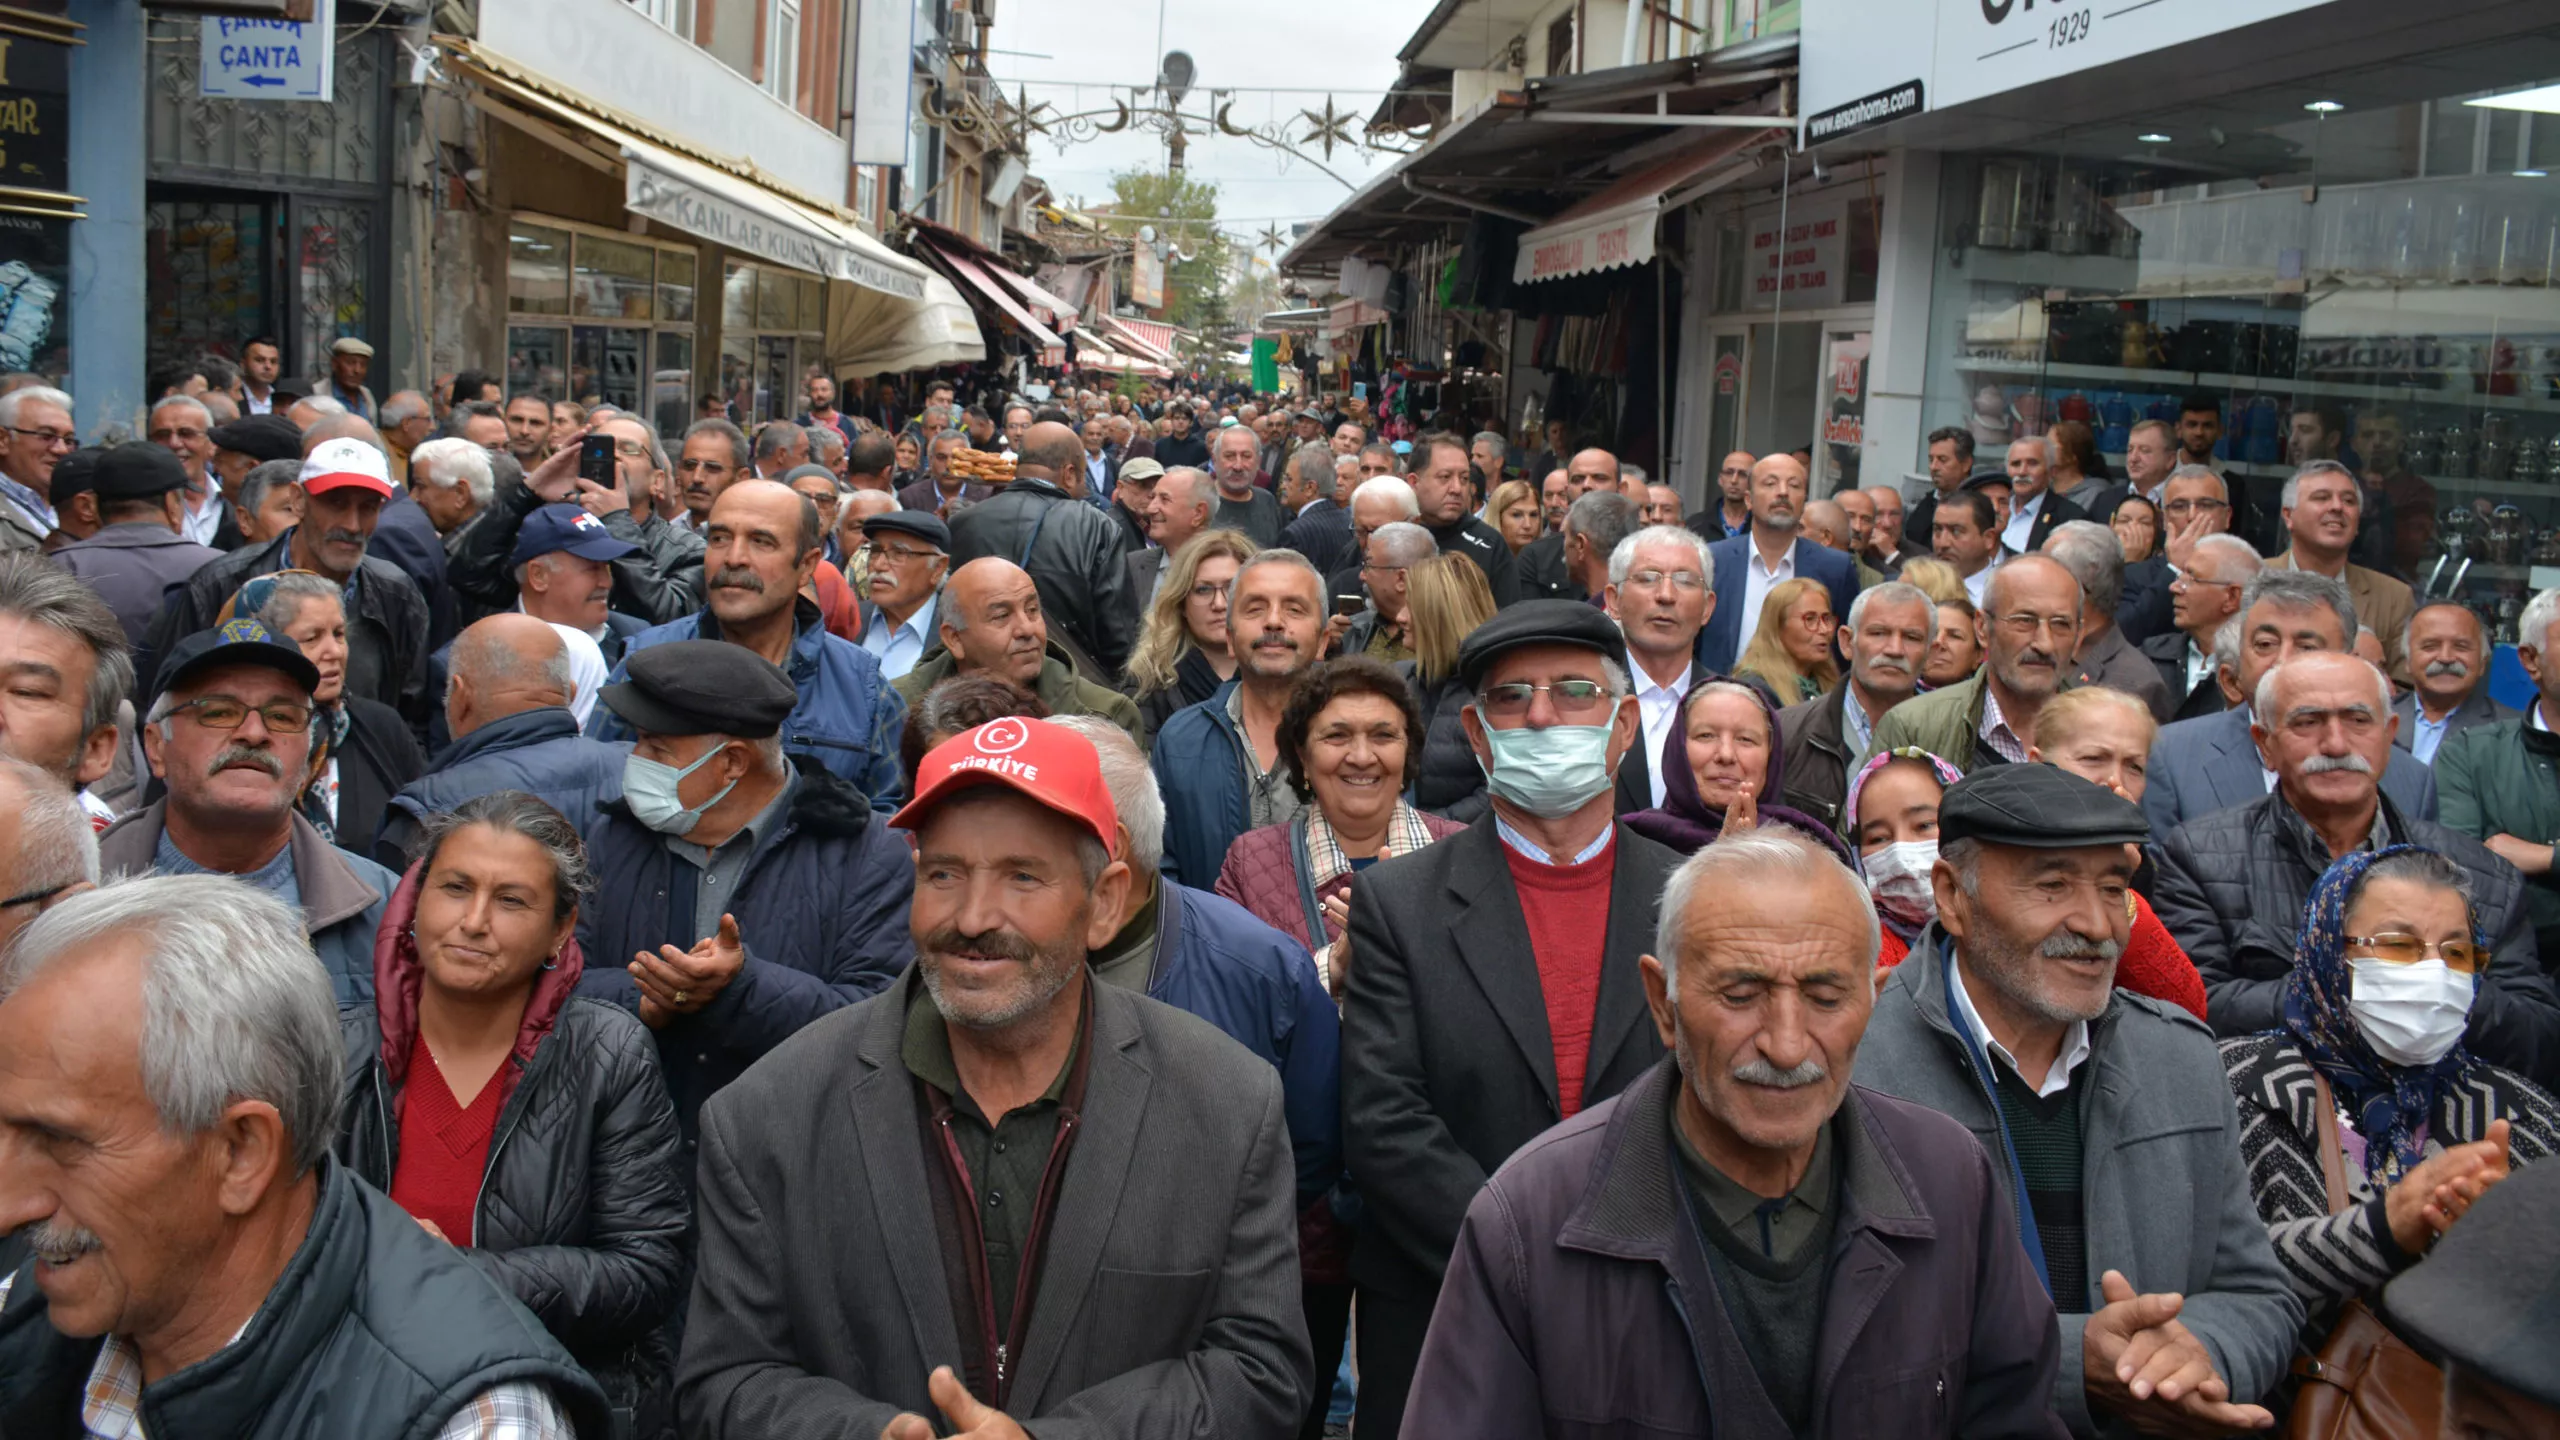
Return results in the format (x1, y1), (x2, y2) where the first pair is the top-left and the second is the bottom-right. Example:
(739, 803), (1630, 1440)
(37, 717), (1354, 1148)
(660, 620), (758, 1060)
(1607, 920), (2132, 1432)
(2281, 846), (2488, 1184)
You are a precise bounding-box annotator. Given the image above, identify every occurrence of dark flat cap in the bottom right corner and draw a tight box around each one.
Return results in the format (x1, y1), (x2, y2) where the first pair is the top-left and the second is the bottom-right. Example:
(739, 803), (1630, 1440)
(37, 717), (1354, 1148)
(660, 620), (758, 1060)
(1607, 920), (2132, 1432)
(2383, 1166), (2560, 1407)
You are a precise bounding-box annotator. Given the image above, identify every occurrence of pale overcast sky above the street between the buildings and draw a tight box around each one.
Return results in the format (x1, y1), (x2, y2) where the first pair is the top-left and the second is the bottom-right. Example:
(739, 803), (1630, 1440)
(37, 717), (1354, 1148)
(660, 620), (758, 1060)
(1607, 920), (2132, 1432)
(986, 0), (1431, 241)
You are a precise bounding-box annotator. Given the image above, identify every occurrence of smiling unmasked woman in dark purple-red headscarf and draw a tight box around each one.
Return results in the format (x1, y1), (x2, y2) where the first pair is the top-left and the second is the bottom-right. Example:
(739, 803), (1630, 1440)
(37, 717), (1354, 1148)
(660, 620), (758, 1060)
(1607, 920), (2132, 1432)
(1626, 674), (1848, 863)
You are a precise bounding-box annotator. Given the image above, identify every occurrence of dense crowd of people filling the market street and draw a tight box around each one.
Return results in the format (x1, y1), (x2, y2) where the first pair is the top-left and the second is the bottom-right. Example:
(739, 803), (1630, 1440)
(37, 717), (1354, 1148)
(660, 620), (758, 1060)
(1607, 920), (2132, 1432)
(0, 358), (2560, 1440)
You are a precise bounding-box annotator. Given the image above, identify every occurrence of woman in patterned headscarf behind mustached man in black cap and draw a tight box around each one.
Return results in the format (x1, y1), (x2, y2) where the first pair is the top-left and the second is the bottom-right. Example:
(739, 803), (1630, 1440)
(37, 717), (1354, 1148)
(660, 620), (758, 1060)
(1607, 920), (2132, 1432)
(215, 569), (428, 853)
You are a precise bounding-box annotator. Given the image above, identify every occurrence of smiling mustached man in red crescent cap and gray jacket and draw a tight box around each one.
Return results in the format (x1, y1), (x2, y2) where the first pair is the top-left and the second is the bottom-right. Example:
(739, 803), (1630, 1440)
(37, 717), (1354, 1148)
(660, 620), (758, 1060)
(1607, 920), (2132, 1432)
(676, 717), (1316, 1440)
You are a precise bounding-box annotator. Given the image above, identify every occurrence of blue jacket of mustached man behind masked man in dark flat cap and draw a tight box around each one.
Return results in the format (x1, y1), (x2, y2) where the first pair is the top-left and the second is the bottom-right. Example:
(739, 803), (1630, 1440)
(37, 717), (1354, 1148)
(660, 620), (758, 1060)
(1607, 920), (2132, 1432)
(586, 589), (911, 799)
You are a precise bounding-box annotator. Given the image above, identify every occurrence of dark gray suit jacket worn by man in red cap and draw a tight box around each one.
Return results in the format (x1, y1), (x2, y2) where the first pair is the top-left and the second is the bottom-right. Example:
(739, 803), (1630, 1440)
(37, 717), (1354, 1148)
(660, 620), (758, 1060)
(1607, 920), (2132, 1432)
(676, 969), (1313, 1440)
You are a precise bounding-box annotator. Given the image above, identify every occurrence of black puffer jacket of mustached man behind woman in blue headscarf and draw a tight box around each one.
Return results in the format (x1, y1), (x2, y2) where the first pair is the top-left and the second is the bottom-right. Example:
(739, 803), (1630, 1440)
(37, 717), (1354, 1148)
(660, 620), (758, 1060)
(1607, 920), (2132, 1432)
(2150, 792), (2560, 1086)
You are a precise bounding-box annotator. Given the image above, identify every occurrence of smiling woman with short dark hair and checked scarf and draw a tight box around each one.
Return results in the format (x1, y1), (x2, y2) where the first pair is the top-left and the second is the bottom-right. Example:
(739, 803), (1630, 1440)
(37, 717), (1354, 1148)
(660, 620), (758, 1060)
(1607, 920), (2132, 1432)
(1219, 656), (1464, 997)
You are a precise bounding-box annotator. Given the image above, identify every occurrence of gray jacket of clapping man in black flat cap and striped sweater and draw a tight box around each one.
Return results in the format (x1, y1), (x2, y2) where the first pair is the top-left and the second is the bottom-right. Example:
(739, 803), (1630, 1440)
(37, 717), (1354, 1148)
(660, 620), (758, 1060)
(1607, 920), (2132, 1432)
(1853, 925), (2301, 1435)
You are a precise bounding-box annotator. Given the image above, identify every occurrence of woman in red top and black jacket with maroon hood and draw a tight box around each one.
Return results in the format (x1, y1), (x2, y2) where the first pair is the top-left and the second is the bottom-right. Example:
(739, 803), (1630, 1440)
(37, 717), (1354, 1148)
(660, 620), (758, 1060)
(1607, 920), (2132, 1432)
(338, 789), (686, 1412)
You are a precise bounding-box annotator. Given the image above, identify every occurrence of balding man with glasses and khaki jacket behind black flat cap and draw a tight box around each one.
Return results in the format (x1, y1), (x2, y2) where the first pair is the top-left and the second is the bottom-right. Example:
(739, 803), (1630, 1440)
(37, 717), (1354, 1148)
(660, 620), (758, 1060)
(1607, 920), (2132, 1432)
(1869, 556), (2084, 774)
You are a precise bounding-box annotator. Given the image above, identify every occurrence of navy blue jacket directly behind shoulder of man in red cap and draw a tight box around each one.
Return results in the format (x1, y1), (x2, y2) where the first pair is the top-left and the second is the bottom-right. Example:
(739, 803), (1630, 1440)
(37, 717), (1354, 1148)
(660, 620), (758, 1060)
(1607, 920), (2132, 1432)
(1147, 881), (1341, 1209)
